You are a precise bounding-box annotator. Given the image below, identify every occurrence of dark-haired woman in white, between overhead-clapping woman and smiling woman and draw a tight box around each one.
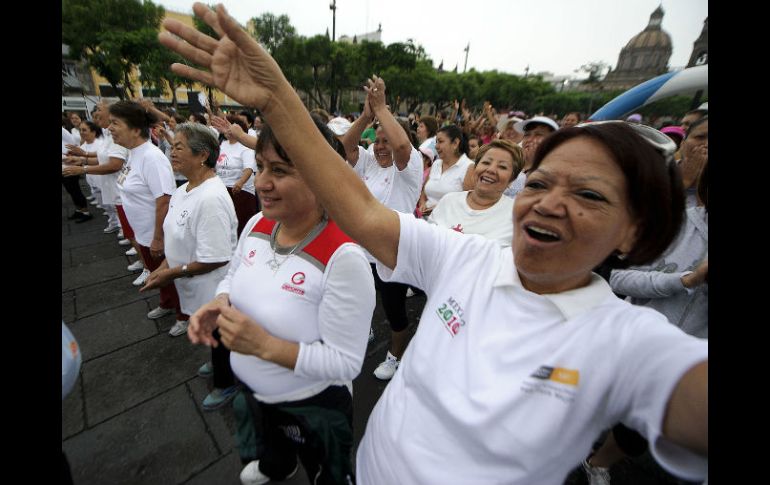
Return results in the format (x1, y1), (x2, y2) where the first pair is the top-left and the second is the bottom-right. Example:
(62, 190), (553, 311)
(419, 125), (473, 217)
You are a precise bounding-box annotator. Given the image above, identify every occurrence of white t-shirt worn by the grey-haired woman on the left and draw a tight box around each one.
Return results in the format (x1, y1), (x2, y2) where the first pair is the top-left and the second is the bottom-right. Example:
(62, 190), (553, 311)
(163, 177), (238, 315)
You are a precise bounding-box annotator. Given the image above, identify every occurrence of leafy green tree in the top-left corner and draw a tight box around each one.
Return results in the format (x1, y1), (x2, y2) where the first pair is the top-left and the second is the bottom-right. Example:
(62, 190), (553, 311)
(62, 0), (165, 99)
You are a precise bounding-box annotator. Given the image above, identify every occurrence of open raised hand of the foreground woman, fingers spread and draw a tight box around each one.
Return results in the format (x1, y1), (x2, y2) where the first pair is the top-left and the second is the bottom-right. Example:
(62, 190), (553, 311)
(158, 2), (291, 111)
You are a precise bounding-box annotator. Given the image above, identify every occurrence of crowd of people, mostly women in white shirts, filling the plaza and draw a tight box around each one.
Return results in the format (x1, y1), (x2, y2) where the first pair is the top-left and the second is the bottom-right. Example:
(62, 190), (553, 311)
(62, 4), (708, 485)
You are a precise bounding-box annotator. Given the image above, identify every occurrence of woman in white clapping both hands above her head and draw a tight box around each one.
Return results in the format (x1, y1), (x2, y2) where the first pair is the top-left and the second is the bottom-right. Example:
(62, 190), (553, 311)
(342, 76), (422, 380)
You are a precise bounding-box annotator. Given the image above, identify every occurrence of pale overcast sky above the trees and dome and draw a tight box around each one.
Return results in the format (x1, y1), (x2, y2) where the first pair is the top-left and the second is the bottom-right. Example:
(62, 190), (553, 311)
(154, 0), (708, 78)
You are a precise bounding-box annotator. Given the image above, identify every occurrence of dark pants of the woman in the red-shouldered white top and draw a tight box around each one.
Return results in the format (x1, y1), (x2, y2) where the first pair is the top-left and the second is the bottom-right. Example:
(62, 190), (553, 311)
(257, 386), (355, 485)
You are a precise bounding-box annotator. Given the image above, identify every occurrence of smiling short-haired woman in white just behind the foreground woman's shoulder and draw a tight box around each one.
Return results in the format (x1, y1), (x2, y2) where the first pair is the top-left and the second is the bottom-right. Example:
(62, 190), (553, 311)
(428, 140), (524, 247)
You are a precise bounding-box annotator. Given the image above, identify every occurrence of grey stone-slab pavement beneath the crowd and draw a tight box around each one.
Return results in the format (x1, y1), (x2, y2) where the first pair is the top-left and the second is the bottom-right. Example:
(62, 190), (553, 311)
(62, 182), (425, 485)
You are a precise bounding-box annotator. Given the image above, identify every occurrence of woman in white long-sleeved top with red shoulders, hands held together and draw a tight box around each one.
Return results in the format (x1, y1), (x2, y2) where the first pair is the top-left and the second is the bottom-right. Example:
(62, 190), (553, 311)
(188, 115), (375, 484)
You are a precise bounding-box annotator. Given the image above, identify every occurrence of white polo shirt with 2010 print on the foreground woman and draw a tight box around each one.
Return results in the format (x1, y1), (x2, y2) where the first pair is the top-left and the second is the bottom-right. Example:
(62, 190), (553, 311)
(356, 214), (708, 485)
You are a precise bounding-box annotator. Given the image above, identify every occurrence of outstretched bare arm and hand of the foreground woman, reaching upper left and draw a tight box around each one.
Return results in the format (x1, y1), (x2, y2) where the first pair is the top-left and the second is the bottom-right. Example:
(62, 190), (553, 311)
(159, 3), (400, 268)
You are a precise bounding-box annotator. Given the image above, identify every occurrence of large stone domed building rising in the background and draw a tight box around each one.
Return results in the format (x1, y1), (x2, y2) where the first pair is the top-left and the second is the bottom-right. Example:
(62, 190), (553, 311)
(602, 6), (672, 90)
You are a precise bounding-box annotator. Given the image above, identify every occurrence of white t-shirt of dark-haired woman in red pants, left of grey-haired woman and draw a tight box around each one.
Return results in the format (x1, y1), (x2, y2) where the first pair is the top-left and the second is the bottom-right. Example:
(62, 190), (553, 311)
(120, 140), (176, 247)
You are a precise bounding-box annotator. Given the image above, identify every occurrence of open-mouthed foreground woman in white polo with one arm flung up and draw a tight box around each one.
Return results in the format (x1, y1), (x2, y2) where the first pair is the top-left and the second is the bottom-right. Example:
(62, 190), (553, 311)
(160, 3), (708, 484)
